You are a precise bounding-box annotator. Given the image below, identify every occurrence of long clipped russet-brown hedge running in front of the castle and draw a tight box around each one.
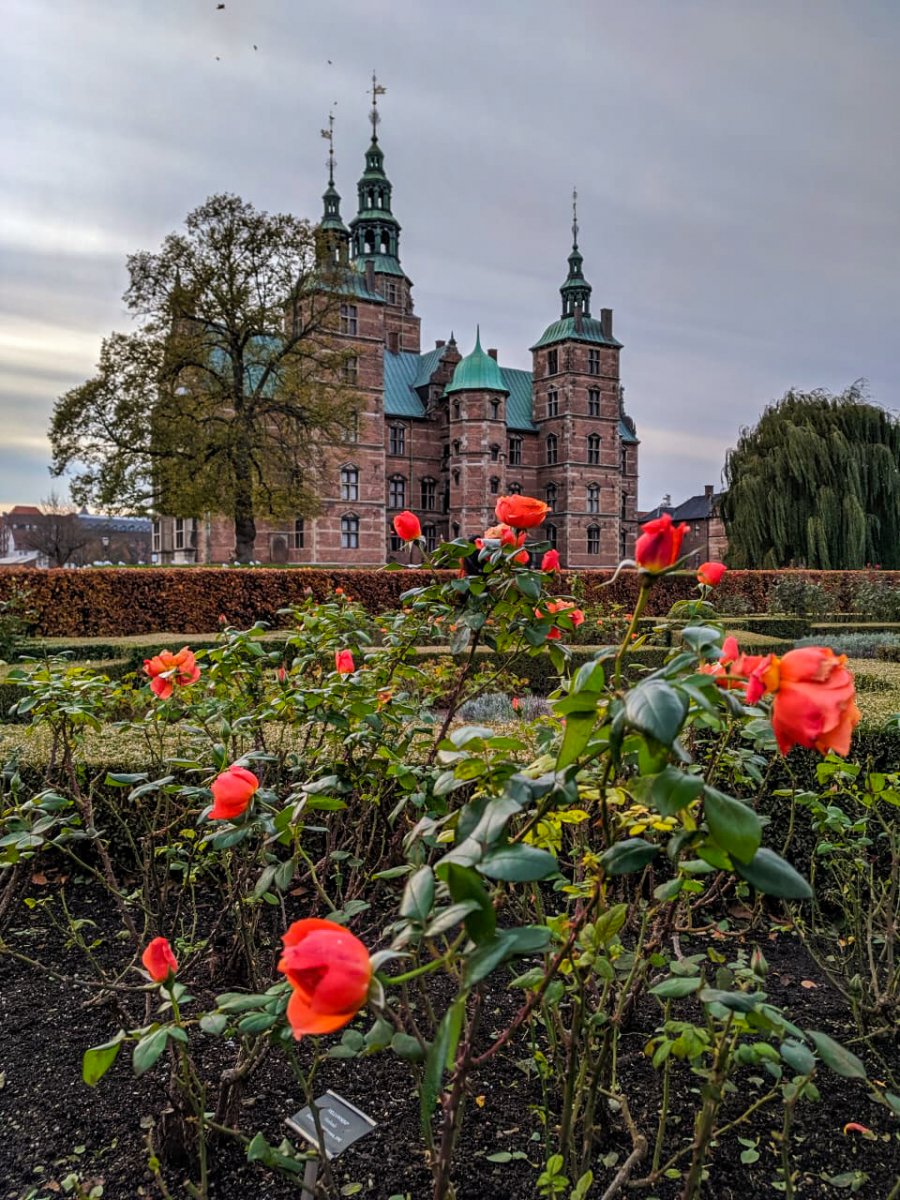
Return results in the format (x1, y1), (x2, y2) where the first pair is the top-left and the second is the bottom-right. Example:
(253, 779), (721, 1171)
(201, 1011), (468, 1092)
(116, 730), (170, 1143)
(0, 566), (900, 637)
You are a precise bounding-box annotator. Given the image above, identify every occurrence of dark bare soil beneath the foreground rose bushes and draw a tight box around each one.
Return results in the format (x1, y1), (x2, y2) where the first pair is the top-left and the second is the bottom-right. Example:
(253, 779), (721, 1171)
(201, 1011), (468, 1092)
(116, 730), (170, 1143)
(0, 886), (900, 1200)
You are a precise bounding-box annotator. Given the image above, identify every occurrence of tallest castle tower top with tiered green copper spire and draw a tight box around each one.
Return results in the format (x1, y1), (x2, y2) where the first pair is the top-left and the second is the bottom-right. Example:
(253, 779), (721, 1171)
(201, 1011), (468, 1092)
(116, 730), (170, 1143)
(350, 73), (420, 354)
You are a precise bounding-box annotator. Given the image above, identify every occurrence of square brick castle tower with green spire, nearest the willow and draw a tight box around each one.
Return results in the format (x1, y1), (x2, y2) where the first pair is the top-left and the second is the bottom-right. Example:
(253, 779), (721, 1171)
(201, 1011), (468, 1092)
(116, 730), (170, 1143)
(532, 193), (637, 568)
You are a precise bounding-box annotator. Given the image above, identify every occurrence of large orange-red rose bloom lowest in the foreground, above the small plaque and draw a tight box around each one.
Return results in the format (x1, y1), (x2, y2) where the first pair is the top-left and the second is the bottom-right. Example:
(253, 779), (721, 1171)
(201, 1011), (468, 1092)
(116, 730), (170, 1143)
(278, 917), (372, 1038)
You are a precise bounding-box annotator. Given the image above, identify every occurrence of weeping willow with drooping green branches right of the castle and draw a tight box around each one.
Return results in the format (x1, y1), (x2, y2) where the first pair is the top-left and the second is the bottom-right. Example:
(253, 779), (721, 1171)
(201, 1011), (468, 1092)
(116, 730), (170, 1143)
(721, 383), (900, 570)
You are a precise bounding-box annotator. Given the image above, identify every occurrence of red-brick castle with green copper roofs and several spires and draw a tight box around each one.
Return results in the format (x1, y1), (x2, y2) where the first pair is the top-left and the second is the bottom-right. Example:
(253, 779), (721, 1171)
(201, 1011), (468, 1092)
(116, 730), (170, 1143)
(154, 86), (638, 568)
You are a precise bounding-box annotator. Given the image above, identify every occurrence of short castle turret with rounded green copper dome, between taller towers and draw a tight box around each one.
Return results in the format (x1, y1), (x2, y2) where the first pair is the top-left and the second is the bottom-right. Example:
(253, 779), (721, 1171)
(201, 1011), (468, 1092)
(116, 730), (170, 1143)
(445, 329), (509, 538)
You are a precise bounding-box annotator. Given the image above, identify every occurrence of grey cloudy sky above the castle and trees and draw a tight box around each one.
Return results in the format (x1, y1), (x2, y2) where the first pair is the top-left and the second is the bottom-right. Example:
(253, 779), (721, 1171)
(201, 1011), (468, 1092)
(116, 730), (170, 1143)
(0, 0), (900, 506)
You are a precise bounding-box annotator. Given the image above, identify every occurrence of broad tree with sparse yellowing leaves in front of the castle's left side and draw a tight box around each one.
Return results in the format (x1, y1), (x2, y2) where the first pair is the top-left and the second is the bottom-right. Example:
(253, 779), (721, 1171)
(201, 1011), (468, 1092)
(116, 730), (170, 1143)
(50, 196), (360, 562)
